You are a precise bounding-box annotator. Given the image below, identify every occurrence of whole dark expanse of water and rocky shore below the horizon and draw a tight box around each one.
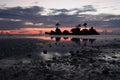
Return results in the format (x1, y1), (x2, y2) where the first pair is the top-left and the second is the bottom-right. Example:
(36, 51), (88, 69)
(0, 35), (120, 80)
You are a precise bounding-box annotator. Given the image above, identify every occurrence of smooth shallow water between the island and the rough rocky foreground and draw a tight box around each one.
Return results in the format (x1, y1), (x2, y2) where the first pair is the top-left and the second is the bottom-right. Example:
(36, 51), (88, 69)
(0, 35), (120, 60)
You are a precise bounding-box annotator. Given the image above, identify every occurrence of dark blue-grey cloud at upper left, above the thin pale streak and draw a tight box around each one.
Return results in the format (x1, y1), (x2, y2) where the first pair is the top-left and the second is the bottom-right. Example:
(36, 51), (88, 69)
(0, 6), (44, 19)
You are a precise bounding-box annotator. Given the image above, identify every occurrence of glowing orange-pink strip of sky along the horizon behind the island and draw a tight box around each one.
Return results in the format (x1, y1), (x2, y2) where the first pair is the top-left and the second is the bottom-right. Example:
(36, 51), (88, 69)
(0, 27), (113, 34)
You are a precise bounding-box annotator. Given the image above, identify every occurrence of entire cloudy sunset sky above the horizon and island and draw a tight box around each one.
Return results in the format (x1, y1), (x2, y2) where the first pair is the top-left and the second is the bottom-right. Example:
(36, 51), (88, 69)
(0, 0), (120, 33)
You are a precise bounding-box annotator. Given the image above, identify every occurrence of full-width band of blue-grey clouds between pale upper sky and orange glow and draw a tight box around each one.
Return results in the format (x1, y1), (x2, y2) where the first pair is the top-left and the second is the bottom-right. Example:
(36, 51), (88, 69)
(0, 5), (120, 29)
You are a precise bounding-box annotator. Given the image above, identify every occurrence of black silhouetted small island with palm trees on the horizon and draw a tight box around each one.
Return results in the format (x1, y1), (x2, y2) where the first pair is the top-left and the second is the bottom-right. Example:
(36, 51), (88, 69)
(45, 23), (99, 35)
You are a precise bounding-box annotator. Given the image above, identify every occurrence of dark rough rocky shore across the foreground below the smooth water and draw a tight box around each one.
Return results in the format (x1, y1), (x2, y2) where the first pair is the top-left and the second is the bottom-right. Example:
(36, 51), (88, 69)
(0, 45), (120, 80)
